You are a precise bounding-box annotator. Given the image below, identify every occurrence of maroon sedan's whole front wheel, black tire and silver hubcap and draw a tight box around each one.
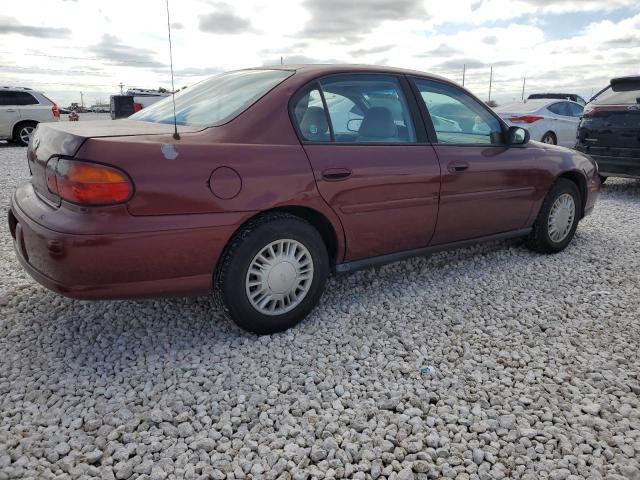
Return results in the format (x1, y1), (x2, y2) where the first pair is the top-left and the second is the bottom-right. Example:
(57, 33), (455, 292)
(527, 178), (582, 253)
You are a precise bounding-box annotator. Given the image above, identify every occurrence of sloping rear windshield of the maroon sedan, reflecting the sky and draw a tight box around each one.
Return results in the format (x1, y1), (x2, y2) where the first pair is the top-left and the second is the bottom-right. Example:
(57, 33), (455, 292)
(129, 70), (293, 127)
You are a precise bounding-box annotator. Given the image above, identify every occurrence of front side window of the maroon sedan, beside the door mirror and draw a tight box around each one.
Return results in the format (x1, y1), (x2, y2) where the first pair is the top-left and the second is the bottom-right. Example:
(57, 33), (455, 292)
(414, 79), (504, 145)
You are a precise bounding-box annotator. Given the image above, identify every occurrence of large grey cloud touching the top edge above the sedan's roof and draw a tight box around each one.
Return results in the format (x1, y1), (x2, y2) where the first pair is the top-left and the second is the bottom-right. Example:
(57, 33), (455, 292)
(301, 0), (428, 43)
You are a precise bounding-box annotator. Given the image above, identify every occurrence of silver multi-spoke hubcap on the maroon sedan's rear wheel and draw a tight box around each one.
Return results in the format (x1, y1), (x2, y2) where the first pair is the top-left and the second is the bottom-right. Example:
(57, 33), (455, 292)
(245, 239), (313, 315)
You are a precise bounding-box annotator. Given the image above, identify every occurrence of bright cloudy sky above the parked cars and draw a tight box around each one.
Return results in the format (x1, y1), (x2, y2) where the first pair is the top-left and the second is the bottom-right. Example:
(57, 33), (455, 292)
(0, 0), (640, 106)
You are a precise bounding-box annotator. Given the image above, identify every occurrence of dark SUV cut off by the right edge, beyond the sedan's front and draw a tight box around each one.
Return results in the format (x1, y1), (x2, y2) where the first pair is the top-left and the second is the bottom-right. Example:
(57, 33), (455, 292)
(576, 76), (640, 181)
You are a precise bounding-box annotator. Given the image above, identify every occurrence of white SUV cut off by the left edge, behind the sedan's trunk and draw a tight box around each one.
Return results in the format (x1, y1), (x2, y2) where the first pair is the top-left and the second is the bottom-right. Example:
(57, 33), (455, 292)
(0, 87), (60, 146)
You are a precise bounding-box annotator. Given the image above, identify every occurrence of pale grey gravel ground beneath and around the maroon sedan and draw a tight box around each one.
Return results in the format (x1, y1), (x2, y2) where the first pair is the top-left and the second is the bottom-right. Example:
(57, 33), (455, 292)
(0, 145), (640, 480)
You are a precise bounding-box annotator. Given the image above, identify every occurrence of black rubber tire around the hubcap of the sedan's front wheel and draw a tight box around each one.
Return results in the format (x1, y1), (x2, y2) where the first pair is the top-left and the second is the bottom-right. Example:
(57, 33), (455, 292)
(527, 178), (582, 253)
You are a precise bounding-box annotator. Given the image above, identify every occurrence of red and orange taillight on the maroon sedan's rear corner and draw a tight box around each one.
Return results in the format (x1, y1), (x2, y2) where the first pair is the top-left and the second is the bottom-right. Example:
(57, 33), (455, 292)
(47, 158), (133, 205)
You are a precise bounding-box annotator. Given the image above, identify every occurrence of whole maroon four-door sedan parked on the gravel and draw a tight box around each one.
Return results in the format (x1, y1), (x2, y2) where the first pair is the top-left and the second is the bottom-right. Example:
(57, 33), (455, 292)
(9, 65), (600, 333)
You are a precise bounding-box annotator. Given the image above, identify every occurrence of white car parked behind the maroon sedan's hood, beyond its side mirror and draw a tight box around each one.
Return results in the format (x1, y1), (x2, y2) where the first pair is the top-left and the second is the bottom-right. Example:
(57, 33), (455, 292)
(495, 98), (584, 147)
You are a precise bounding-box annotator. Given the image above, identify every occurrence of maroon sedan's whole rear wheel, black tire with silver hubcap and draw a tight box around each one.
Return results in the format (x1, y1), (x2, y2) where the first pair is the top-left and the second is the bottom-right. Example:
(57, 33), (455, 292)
(214, 213), (329, 335)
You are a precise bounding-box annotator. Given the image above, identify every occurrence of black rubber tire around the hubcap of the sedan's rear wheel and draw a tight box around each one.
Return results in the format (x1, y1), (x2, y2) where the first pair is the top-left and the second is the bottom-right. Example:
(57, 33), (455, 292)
(214, 213), (329, 335)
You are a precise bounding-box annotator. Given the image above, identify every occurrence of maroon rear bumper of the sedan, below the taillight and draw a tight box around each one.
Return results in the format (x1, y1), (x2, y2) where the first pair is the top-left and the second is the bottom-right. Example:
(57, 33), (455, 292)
(8, 183), (246, 299)
